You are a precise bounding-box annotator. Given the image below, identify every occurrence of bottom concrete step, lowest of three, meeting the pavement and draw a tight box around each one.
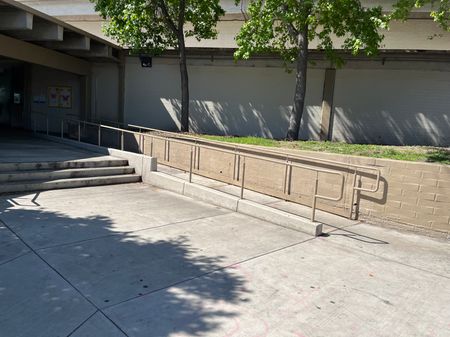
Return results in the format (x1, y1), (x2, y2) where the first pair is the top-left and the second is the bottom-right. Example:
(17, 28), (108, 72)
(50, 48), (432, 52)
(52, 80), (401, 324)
(0, 174), (141, 194)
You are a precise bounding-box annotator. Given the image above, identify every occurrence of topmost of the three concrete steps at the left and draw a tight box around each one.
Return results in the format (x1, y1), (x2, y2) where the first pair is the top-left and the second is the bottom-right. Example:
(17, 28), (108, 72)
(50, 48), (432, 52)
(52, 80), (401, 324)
(0, 158), (128, 172)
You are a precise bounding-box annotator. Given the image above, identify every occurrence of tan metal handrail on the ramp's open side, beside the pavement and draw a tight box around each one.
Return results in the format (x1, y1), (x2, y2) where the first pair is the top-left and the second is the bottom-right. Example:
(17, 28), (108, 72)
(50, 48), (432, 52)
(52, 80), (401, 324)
(30, 115), (345, 222)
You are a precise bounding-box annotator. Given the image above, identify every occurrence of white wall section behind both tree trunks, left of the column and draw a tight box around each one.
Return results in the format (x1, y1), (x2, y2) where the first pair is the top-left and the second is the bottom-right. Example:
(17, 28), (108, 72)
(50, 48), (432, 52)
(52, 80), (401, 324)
(125, 58), (324, 139)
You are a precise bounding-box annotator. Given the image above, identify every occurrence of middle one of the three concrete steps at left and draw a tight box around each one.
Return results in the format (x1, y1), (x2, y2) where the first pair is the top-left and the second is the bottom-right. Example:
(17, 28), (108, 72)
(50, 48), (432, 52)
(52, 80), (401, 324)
(0, 166), (134, 183)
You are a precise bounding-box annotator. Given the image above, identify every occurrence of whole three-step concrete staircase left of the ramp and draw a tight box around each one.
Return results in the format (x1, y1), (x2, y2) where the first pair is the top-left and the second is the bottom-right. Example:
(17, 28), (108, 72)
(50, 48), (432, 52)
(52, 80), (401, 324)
(0, 158), (141, 194)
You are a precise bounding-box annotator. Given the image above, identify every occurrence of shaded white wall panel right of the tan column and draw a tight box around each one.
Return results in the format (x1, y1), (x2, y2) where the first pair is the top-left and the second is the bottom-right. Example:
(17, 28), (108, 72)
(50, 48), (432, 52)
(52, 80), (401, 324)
(333, 69), (450, 146)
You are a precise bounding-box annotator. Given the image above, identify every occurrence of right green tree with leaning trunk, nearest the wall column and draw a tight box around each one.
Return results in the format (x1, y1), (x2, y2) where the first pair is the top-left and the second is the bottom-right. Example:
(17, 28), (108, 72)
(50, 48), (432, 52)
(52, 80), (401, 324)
(235, 0), (450, 140)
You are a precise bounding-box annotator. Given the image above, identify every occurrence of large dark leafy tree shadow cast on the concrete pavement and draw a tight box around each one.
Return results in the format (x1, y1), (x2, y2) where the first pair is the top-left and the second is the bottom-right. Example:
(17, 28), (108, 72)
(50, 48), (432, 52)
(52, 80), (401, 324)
(0, 197), (248, 337)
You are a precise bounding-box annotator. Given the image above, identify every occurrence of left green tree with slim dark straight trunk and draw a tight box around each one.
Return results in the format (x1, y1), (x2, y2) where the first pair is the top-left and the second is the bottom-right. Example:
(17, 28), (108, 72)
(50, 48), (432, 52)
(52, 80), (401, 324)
(91, 0), (224, 132)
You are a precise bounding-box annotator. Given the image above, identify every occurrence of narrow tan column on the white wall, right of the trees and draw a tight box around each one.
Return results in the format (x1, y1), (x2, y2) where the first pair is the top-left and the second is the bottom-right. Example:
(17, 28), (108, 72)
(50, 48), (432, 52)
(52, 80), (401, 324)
(320, 69), (336, 140)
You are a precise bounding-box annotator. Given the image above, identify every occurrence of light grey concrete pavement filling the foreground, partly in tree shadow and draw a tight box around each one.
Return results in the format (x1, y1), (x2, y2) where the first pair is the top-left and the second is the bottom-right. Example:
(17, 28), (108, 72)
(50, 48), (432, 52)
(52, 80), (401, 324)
(0, 184), (450, 337)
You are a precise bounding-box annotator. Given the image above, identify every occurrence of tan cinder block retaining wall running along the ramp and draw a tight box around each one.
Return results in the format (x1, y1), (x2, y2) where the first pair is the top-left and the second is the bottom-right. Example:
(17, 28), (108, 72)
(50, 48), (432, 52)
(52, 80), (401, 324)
(143, 137), (450, 235)
